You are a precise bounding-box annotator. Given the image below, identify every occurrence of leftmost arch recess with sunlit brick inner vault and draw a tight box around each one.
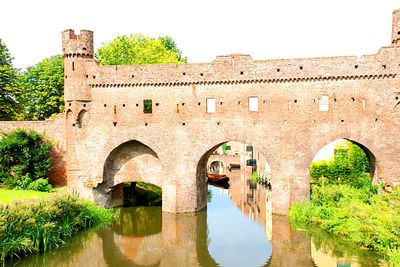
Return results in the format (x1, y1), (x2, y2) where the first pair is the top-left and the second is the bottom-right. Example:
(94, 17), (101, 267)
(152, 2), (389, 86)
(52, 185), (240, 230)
(93, 140), (162, 207)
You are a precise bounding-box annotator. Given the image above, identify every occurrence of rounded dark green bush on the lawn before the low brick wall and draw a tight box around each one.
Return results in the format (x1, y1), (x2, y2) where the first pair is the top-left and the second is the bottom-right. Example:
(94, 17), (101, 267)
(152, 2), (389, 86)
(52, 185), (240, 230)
(0, 129), (52, 191)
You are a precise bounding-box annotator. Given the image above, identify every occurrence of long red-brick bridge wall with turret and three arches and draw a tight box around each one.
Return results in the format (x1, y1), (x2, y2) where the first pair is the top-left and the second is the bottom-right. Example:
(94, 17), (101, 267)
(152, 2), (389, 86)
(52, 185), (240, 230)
(0, 10), (400, 217)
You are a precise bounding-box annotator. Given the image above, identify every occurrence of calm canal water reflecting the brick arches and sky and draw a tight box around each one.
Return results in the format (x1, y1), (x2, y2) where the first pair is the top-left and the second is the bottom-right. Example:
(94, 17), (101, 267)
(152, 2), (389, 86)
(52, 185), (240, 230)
(8, 171), (379, 267)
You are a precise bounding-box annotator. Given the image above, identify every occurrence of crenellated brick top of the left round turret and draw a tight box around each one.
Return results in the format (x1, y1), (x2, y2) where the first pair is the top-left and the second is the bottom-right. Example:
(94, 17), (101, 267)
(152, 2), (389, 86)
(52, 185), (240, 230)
(62, 29), (94, 58)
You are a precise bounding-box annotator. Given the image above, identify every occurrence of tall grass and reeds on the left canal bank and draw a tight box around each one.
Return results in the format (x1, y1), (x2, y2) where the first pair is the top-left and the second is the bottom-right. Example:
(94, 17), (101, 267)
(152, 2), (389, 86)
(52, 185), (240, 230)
(0, 193), (112, 265)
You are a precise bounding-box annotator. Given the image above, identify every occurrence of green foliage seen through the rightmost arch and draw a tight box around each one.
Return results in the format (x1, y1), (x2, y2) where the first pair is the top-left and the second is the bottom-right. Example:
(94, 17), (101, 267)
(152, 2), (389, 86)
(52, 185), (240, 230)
(310, 142), (371, 188)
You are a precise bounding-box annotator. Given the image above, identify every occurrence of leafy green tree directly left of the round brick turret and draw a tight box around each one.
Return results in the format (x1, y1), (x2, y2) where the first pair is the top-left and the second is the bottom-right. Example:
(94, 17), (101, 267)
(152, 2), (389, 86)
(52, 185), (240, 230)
(21, 55), (64, 120)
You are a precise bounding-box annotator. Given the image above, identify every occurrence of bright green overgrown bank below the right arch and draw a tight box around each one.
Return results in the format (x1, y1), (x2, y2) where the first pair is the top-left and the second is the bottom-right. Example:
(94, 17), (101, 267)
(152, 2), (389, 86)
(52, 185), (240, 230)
(289, 184), (400, 266)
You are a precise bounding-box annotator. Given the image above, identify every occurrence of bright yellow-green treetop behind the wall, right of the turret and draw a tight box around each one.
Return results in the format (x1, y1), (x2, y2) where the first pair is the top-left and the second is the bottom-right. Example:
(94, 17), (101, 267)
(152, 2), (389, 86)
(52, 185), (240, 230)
(96, 34), (187, 65)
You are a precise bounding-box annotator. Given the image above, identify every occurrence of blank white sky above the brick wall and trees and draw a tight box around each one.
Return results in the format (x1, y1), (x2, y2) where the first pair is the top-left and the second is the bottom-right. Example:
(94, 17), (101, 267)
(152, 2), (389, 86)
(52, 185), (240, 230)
(0, 0), (400, 68)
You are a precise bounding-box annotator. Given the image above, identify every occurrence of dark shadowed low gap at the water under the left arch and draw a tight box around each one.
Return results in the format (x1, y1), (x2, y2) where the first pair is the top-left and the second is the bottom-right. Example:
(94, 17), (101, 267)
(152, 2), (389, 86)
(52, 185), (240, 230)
(124, 182), (162, 207)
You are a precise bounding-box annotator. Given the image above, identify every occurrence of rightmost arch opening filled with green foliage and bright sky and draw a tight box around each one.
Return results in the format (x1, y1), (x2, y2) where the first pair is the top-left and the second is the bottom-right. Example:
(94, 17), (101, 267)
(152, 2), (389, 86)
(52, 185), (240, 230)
(310, 138), (377, 187)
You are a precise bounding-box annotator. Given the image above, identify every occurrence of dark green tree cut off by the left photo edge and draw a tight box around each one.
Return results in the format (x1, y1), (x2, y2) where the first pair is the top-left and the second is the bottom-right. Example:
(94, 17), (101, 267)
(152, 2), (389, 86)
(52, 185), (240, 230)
(0, 39), (19, 120)
